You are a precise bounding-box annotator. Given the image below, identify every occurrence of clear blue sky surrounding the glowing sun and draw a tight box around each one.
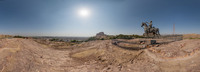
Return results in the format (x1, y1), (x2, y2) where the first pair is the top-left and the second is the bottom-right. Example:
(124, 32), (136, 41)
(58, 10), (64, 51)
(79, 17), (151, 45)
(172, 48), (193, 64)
(0, 0), (200, 36)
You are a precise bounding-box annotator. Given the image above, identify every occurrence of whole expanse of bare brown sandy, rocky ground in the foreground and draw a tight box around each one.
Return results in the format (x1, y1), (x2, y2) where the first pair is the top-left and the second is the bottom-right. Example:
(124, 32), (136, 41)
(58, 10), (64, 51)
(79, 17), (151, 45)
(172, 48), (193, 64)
(0, 38), (200, 72)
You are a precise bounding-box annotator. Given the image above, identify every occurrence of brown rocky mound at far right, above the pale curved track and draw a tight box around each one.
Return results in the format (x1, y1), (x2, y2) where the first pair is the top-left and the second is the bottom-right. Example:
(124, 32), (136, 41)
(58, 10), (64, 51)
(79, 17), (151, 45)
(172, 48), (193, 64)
(149, 40), (200, 59)
